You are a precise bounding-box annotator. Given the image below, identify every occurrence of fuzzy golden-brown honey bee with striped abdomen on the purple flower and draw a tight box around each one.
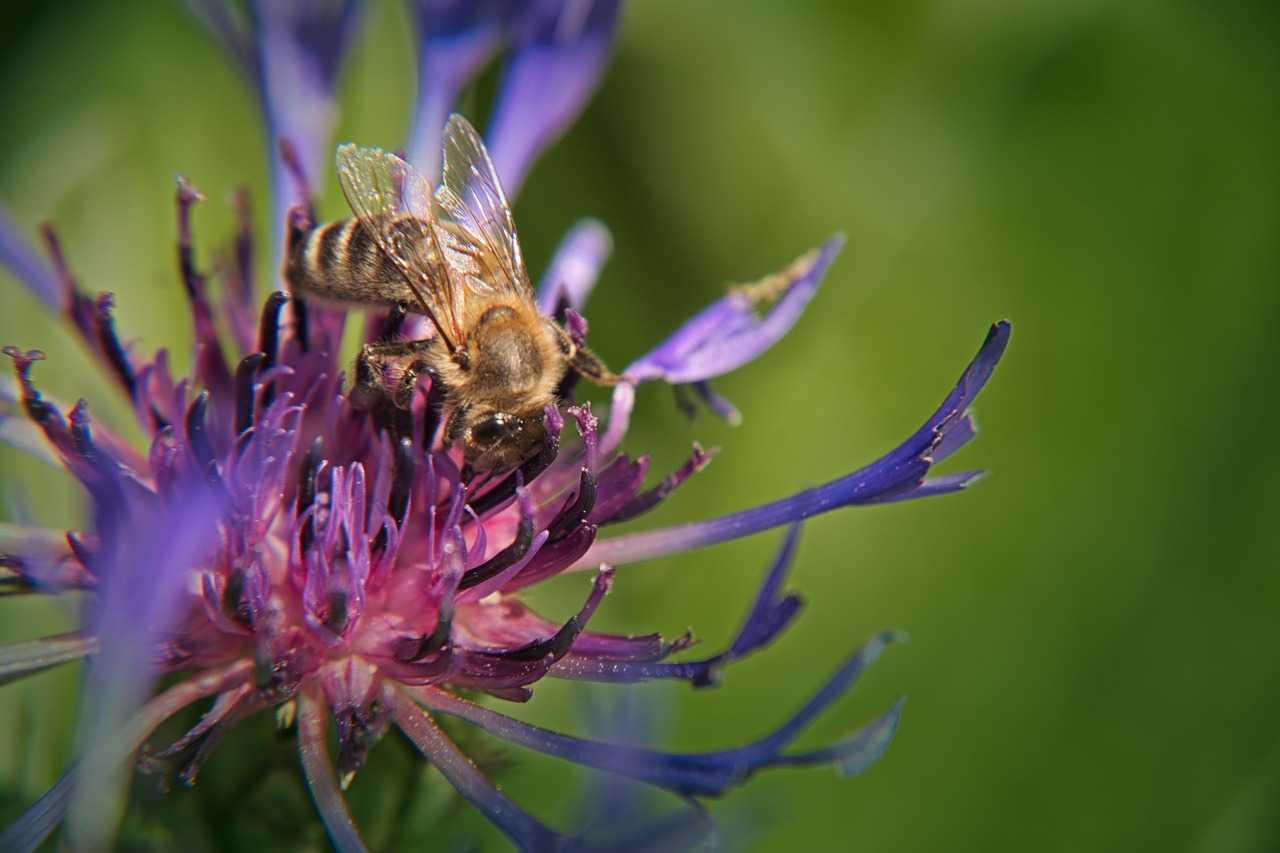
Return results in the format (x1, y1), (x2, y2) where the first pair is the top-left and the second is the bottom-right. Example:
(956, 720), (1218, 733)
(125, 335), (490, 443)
(284, 114), (618, 471)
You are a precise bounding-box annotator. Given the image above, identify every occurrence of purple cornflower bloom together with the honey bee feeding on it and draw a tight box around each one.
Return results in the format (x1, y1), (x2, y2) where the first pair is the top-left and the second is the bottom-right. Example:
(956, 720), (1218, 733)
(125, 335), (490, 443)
(0, 0), (1009, 850)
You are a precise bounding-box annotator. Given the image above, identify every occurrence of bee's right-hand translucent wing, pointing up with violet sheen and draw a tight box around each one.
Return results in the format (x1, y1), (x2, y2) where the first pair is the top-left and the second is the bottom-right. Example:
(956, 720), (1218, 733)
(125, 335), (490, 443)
(435, 113), (534, 302)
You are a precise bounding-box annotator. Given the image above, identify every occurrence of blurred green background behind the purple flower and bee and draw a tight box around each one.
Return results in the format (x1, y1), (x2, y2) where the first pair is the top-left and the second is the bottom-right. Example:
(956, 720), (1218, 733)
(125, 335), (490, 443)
(0, 0), (1280, 852)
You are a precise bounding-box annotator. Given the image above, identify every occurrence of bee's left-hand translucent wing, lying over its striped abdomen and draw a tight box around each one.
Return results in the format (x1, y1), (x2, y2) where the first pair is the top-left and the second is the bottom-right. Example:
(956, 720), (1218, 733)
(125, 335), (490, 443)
(334, 142), (463, 350)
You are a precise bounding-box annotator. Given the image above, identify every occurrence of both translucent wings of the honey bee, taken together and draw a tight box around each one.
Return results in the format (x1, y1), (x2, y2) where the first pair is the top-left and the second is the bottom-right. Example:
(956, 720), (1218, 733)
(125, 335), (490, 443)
(335, 114), (534, 350)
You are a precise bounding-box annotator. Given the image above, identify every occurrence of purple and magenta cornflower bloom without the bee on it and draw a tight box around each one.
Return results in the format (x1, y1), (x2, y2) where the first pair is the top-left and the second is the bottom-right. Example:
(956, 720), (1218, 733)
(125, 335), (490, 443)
(0, 0), (1009, 850)
